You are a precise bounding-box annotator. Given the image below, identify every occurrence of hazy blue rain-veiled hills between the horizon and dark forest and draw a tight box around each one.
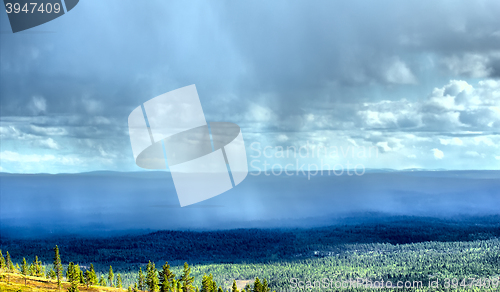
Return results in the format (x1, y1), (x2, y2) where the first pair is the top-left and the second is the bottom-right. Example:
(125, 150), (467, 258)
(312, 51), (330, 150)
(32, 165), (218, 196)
(0, 170), (500, 236)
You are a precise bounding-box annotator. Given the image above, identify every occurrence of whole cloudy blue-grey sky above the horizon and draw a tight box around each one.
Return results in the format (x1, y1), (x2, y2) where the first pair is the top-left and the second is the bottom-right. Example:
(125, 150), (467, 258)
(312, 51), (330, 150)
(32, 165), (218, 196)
(0, 0), (500, 173)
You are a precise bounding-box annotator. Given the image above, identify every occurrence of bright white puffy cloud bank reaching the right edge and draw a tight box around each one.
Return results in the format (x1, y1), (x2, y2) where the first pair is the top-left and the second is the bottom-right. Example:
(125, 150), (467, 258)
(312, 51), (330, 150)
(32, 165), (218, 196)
(357, 80), (500, 132)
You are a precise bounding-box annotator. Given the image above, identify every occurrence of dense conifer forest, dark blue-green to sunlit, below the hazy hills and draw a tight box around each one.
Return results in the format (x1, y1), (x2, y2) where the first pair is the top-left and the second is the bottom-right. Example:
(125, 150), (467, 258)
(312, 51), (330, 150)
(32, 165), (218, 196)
(0, 216), (500, 292)
